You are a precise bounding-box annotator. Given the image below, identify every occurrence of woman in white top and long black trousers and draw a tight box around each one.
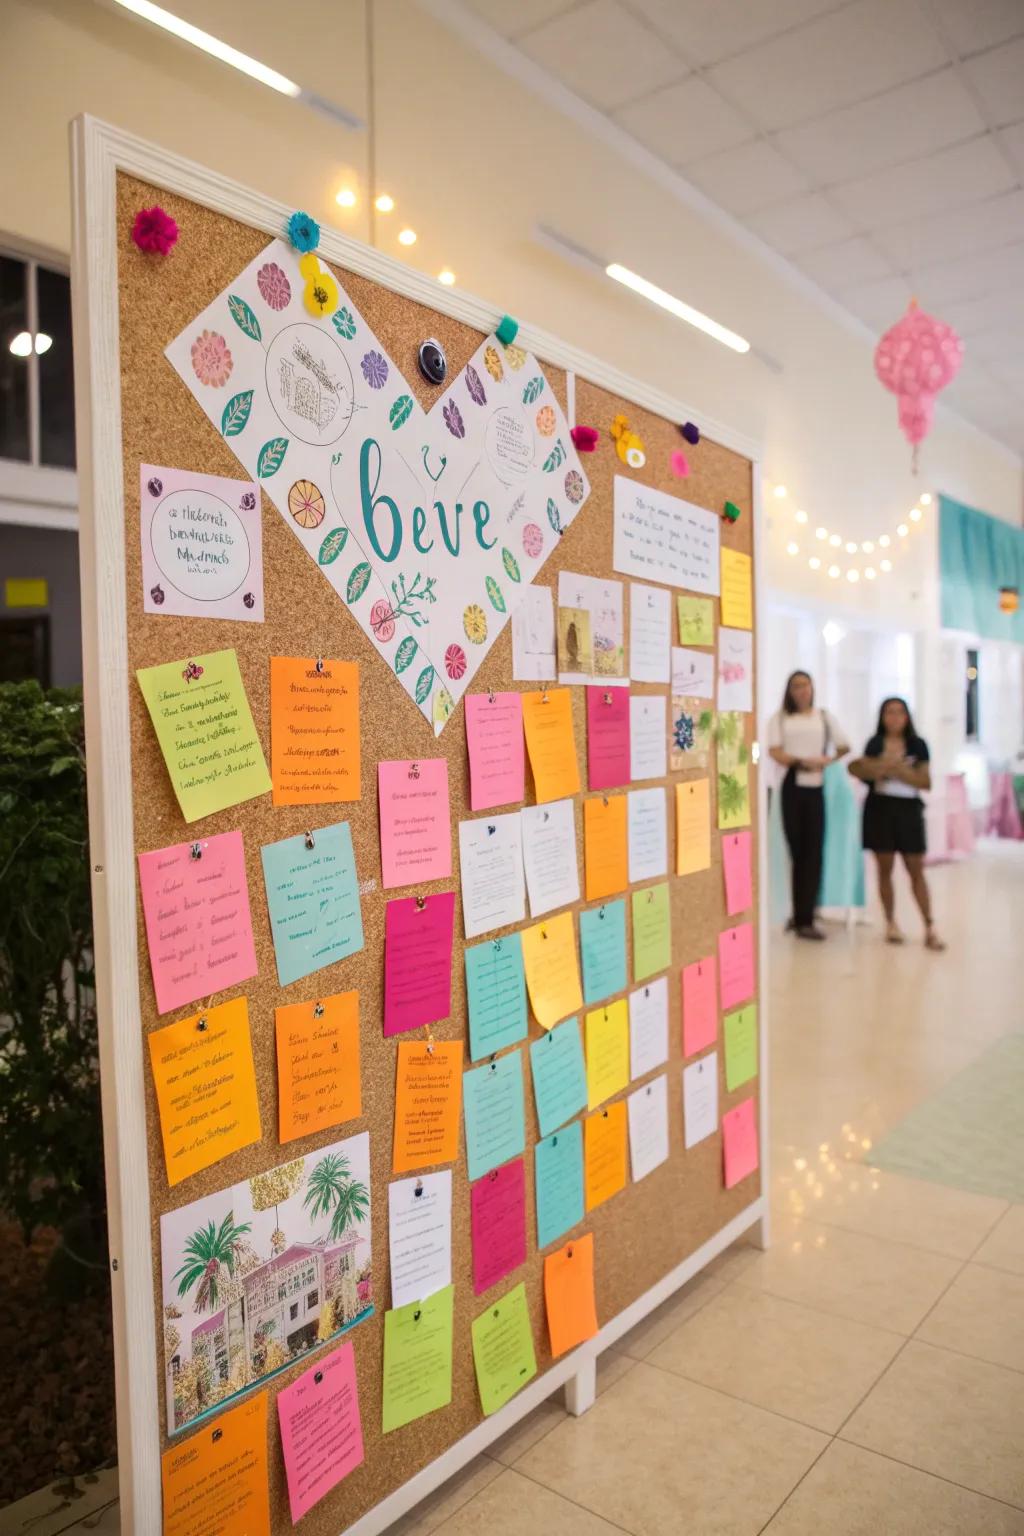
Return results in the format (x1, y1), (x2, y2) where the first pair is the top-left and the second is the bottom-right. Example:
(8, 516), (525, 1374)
(768, 671), (849, 940)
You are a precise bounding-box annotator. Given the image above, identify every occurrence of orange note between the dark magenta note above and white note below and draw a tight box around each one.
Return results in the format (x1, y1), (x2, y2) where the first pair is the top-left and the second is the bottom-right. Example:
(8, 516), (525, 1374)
(393, 1040), (462, 1174)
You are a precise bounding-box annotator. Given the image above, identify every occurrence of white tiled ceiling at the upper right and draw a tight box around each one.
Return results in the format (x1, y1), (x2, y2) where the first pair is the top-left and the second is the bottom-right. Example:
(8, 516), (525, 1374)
(468, 0), (1024, 455)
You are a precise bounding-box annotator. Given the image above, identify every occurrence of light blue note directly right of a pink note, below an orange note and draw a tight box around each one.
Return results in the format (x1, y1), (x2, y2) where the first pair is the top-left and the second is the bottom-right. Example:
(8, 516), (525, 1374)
(261, 822), (362, 986)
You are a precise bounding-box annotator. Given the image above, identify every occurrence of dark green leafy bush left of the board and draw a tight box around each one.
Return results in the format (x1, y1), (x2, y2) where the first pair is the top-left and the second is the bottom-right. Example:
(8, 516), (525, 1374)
(0, 682), (106, 1249)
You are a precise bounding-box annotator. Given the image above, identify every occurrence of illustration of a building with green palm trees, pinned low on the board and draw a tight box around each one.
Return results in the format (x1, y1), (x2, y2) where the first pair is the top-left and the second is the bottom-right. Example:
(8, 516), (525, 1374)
(160, 1130), (373, 1435)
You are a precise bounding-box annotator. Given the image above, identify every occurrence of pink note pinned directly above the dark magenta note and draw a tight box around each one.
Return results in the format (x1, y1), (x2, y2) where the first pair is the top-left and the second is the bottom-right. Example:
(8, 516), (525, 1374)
(378, 757), (451, 889)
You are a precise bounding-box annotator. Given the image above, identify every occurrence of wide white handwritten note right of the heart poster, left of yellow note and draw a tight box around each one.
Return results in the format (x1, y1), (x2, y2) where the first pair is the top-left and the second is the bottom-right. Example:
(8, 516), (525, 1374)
(611, 475), (718, 596)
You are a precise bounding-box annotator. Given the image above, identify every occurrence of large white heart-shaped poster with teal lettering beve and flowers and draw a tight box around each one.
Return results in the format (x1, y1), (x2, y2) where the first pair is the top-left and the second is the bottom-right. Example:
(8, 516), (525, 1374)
(166, 240), (590, 736)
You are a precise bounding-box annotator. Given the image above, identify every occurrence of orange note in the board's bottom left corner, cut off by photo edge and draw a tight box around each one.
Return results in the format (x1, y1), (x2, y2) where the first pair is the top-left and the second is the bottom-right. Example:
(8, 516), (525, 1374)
(160, 1392), (270, 1536)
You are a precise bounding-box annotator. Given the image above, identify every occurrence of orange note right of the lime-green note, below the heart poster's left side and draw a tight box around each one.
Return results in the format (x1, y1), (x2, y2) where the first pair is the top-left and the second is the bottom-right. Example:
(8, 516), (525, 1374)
(270, 656), (359, 805)
